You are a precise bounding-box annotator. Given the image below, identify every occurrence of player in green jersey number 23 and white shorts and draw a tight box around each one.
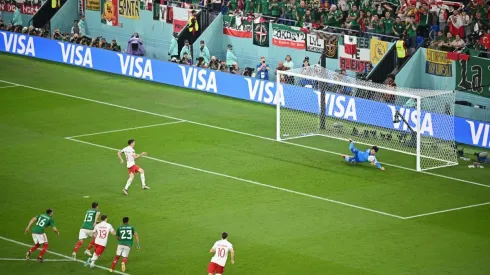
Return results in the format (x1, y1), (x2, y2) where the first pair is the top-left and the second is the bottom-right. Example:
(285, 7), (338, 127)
(110, 217), (140, 272)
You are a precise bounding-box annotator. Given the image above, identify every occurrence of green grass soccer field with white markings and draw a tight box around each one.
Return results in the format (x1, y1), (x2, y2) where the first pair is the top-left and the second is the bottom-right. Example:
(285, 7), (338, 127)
(0, 54), (490, 275)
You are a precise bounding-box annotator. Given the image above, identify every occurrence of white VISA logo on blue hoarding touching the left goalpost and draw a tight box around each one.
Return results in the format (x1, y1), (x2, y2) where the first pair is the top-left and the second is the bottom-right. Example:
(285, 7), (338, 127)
(245, 78), (285, 106)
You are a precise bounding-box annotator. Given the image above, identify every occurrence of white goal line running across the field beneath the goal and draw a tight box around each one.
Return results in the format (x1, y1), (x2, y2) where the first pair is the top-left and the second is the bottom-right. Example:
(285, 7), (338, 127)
(0, 80), (490, 191)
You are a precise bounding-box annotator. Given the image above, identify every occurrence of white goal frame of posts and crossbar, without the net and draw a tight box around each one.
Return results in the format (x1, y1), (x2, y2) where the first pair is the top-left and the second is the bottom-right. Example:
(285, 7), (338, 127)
(276, 65), (458, 172)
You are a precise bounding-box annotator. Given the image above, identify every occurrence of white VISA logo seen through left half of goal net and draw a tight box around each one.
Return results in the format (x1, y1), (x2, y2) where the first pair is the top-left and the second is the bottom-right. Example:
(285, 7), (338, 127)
(315, 91), (357, 121)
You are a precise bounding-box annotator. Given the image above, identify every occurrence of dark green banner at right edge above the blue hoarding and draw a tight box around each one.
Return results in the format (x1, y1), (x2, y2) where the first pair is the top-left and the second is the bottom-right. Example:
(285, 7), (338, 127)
(456, 56), (490, 98)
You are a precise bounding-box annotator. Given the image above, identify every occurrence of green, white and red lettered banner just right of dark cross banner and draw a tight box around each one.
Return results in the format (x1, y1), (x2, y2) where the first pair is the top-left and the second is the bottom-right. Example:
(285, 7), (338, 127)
(272, 24), (306, 50)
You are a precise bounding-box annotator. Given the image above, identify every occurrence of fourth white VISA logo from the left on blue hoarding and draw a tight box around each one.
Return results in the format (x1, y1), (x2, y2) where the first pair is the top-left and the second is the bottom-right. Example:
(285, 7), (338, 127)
(179, 65), (218, 93)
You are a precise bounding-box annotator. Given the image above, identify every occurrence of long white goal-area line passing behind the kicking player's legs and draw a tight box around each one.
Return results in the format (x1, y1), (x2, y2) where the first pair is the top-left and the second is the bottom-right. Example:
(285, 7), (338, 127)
(66, 138), (403, 219)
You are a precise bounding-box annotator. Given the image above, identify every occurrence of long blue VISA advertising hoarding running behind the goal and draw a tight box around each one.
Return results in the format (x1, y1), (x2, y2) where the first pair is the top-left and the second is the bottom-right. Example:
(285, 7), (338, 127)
(0, 32), (490, 148)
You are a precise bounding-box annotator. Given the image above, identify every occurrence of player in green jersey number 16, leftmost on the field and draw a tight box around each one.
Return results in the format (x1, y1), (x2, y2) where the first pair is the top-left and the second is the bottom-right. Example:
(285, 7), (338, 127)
(25, 209), (60, 263)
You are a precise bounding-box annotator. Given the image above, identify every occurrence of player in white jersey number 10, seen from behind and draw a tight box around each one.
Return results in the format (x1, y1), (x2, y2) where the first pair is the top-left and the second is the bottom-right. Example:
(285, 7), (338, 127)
(208, 232), (235, 275)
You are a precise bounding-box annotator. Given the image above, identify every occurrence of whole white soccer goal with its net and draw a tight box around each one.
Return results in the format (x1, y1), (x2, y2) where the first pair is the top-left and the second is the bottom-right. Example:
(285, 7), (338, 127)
(276, 65), (458, 171)
